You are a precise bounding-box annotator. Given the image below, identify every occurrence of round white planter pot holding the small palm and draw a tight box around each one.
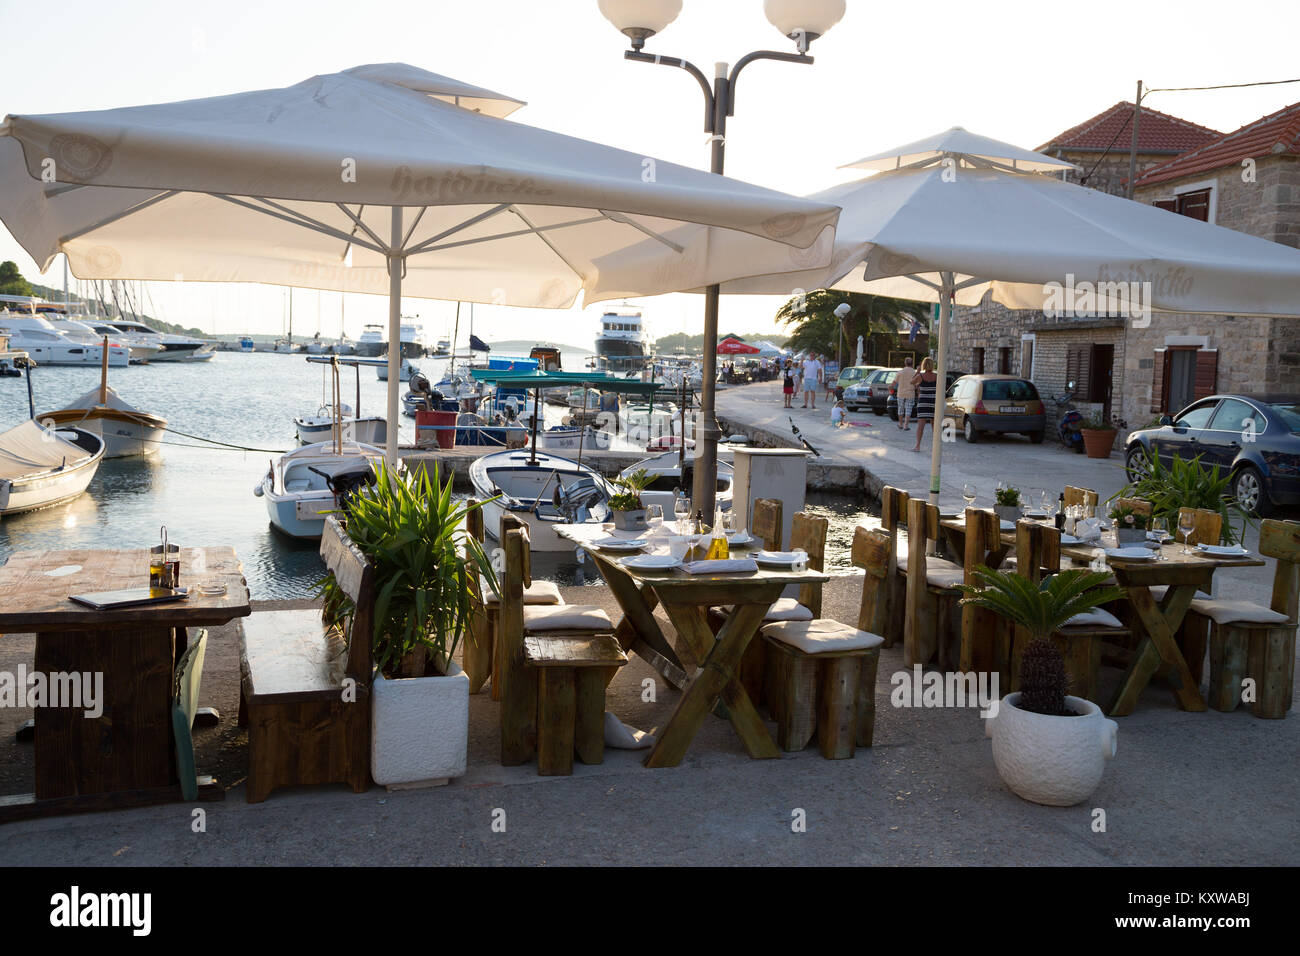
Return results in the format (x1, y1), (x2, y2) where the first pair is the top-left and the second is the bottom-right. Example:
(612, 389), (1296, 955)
(984, 693), (1119, 806)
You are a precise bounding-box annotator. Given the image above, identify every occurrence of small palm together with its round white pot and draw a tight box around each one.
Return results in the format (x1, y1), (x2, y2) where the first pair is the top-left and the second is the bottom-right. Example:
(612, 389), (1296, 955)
(959, 567), (1125, 806)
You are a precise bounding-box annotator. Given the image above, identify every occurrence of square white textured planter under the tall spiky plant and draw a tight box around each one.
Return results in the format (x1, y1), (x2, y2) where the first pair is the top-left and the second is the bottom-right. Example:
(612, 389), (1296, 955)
(371, 662), (469, 790)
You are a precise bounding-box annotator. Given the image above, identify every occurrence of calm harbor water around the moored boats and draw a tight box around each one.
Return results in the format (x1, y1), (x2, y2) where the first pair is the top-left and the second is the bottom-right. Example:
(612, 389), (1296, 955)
(0, 347), (861, 600)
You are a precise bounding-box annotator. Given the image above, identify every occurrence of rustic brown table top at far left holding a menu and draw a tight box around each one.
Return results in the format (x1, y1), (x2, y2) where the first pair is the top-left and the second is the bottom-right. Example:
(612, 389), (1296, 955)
(0, 548), (252, 633)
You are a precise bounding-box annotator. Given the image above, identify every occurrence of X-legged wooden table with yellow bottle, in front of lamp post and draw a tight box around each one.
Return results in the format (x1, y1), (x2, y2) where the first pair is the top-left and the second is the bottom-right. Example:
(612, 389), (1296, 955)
(555, 524), (831, 767)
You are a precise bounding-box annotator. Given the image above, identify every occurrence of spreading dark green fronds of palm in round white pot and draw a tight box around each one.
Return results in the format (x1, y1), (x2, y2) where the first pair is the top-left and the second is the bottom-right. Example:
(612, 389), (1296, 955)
(957, 566), (1125, 640)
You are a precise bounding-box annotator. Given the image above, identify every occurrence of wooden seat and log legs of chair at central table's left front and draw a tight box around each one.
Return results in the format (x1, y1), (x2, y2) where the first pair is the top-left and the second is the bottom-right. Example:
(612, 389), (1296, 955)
(524, 633), (628, 777)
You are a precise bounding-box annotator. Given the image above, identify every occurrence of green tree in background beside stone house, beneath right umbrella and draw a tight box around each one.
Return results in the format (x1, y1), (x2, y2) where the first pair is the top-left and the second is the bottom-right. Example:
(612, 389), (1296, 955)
(776, 289), (931, 360)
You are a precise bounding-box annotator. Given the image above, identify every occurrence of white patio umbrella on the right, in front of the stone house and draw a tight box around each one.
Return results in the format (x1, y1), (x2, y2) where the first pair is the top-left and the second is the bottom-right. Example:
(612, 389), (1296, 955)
(676, 129), (1300, 502)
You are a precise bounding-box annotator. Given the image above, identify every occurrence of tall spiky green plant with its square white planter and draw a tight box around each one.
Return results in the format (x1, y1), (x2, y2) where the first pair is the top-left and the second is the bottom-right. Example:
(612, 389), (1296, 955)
(320, 463), (497, 788)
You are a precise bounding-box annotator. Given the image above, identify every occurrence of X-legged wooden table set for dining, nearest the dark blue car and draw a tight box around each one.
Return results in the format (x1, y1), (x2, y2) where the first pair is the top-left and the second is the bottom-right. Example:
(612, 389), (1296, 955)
(940, 518), (1266, 717)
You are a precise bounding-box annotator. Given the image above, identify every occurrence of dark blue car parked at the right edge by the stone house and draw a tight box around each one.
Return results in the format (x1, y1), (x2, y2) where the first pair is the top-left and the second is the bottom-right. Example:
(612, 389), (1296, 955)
(1125, 393), (1300, 516)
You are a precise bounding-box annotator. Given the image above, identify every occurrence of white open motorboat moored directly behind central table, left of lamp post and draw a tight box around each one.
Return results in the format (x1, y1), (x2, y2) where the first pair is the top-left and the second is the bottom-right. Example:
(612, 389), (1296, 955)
(469, 450), (612, 551)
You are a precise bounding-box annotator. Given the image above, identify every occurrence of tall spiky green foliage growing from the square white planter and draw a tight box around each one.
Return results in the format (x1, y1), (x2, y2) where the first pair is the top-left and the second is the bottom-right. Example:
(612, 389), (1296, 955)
(317, 462), (498, 678)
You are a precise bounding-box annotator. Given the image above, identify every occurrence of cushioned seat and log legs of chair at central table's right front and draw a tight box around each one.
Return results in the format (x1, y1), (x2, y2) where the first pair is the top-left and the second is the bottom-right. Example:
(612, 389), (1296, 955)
(761, 618), (884, 760)
